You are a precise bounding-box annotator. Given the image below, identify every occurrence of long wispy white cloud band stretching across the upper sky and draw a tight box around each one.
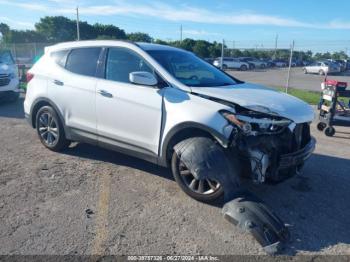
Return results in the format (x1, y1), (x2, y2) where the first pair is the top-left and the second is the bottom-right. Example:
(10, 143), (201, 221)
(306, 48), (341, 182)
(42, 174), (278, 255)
(0, 0), (350, 29)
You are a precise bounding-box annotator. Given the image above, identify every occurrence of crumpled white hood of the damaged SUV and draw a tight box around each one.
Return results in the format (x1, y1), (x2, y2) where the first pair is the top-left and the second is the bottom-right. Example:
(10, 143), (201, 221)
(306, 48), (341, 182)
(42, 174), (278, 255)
(191, 83), (314, 123)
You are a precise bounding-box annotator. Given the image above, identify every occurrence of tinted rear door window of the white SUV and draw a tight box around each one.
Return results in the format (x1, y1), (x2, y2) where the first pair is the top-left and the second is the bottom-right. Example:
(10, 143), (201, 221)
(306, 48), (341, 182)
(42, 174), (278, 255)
(66, 47), (101, 76)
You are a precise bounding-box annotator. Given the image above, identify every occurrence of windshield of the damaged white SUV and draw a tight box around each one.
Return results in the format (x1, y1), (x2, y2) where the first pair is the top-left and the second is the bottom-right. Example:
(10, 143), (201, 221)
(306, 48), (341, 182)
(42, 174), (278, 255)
(147, 50), (237, 87)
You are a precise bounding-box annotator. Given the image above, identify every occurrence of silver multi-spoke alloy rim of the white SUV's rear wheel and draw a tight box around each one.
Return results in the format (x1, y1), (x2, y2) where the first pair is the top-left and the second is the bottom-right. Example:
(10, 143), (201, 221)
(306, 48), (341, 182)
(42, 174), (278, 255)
(38, 112), (59, 146)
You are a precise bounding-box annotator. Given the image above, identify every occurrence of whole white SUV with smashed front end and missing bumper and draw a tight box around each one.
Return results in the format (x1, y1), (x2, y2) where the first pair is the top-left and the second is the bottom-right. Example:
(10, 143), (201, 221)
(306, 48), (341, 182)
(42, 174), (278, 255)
(24, 41), (315, 201)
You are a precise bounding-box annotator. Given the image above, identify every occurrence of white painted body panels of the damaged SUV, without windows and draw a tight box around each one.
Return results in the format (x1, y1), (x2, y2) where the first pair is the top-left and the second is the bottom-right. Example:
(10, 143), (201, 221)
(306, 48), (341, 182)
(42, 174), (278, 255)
(24, 41), (313, 164)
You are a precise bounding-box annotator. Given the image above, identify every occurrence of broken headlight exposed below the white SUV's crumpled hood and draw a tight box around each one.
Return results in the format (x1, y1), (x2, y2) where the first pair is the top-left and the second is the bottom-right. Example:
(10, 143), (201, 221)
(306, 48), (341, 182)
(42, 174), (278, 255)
(220, 110), (292, 135)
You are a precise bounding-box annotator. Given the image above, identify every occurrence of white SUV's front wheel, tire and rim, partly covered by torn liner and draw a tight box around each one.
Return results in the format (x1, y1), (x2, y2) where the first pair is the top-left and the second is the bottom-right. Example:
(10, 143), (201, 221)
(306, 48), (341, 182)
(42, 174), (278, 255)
(171, 151), (224, 203)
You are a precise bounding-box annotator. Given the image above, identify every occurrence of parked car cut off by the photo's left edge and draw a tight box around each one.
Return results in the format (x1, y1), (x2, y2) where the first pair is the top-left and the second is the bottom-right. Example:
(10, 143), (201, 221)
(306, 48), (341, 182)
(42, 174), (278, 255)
(0, 51), (19, 101)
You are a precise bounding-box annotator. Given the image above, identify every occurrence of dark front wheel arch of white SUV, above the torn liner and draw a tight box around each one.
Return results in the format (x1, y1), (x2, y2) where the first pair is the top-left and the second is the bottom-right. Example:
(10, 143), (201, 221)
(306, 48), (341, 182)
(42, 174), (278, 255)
(166, 127), (217, 166)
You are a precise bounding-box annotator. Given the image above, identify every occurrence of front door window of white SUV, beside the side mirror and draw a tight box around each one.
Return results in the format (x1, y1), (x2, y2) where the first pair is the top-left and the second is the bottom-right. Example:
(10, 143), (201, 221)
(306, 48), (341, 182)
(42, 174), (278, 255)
(106, 48), (153, 83)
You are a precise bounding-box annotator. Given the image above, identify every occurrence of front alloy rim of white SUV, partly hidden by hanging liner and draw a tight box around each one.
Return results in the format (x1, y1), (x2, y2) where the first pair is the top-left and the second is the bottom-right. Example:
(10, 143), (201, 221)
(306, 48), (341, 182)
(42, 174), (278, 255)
(179, 161), (221, 195)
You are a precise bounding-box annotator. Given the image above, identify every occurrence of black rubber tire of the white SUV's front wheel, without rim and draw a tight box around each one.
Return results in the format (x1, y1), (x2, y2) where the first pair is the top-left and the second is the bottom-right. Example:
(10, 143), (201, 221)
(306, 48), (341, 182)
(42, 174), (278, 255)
(171, 151), (224, 203)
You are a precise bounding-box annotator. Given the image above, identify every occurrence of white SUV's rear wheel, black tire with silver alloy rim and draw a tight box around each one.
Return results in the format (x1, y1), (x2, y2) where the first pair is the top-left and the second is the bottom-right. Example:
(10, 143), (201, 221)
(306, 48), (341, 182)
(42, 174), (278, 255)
(35, 106), (70, 152)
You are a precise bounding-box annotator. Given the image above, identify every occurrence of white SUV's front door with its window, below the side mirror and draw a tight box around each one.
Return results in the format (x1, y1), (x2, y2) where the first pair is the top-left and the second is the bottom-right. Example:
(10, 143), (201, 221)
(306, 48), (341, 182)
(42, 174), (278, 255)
(96, 47), (162, 156)
